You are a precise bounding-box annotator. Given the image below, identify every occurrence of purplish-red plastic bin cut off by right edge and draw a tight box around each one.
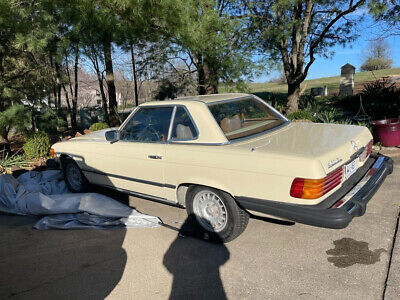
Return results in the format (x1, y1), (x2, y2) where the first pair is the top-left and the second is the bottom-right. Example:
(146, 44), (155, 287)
(371, 118), (400, 147)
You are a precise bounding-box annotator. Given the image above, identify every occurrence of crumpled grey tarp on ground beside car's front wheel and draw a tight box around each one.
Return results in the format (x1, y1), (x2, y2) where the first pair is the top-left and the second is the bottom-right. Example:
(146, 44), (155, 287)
(0, 170), (161, 230)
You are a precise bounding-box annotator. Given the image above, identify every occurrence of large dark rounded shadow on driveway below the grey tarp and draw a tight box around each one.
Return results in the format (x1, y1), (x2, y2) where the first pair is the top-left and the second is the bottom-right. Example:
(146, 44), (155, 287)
(0, 190), (127, 299)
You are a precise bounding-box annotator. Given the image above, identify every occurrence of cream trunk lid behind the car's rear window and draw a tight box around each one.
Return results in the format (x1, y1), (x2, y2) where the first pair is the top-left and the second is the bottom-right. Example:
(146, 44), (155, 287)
(231, 122), (372, 173)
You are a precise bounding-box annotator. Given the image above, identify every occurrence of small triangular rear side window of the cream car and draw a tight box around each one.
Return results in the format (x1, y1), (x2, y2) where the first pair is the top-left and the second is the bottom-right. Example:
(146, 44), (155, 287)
(171, 107), (197, 140)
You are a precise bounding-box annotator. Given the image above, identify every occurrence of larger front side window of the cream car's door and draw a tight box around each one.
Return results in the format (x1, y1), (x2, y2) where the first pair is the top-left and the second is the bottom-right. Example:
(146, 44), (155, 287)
(121, 107), (173, 142)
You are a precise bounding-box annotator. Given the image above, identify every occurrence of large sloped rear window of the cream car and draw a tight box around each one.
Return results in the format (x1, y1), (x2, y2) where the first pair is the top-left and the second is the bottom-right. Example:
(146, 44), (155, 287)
(208, 98), (286, 140)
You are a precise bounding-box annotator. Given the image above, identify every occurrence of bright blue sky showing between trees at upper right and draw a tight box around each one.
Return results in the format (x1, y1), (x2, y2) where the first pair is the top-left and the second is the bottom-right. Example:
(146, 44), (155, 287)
(254, 16), (400, 82)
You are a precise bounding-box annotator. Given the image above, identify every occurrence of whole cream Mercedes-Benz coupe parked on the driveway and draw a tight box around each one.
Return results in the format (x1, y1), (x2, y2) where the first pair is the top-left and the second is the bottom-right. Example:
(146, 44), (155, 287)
(52, 94), (393, 242)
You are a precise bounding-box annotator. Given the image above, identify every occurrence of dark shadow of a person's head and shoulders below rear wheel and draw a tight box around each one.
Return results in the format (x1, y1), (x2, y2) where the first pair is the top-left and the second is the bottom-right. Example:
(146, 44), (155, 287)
(163, 219), (230, 299)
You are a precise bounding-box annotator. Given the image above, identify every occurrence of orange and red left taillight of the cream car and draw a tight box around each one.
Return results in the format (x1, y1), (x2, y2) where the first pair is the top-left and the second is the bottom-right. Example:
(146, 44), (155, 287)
(290, 167), (343, 199)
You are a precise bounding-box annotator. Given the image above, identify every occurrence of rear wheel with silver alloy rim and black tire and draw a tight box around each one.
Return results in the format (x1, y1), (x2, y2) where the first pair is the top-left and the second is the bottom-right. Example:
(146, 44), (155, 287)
(186, 186), (249, 243)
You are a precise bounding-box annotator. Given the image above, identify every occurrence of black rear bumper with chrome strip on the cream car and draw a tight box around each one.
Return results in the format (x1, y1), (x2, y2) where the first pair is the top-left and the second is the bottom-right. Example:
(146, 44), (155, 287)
(235, 155), (393, 229)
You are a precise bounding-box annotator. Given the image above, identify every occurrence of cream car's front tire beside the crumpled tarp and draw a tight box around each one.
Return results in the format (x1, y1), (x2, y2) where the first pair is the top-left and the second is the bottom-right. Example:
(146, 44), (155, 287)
(62, 158), (89, 193)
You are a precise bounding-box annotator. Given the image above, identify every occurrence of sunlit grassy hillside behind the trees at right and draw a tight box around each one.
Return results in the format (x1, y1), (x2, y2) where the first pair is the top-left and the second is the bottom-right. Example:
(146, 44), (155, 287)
(244, 68), (400, 93)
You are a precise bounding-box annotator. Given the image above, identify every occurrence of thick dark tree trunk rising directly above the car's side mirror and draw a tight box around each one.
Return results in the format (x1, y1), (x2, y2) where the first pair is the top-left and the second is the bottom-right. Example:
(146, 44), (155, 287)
(104, 43), (120, 127)
